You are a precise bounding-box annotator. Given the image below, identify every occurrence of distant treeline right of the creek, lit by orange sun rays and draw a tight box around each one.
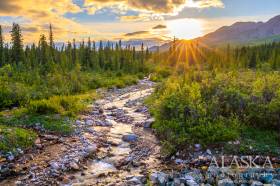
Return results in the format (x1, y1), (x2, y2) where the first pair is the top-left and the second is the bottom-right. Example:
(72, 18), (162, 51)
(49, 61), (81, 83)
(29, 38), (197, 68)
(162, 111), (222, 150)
(153, 39), (280, 70)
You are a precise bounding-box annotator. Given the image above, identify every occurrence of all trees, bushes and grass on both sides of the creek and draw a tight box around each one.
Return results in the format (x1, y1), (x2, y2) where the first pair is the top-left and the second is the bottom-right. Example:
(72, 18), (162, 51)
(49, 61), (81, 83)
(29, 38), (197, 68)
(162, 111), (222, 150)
(0, 24), (280, 157)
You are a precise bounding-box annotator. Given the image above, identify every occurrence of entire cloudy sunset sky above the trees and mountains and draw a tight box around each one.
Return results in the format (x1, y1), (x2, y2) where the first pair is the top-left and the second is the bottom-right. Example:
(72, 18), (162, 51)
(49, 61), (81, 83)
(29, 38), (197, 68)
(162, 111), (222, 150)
(0, 0), (280, 45)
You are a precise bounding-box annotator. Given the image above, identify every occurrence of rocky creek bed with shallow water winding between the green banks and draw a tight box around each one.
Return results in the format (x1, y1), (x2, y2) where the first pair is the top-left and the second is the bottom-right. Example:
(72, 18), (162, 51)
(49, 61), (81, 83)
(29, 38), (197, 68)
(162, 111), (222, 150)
(0, 79), (280, 186)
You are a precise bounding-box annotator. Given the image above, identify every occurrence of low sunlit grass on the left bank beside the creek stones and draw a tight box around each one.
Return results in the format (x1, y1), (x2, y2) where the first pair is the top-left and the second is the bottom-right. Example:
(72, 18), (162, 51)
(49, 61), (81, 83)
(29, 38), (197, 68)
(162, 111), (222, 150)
(0, 92), (98, 152)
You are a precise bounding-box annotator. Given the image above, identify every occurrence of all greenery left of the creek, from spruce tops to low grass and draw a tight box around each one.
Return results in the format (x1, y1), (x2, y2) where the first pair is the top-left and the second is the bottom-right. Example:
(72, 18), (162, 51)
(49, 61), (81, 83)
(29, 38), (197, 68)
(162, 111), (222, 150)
(0, 24), (150, 151)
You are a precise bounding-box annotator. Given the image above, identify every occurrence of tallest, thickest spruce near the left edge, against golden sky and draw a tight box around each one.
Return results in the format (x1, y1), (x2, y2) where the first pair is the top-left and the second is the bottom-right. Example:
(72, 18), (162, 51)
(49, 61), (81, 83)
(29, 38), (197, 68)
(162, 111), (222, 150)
(11, 23), (23, 64)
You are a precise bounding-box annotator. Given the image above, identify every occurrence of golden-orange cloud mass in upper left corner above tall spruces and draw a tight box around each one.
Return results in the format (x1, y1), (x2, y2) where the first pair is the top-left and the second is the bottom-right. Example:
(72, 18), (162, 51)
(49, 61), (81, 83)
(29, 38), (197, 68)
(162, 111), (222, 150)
(0, 0), (86, 42)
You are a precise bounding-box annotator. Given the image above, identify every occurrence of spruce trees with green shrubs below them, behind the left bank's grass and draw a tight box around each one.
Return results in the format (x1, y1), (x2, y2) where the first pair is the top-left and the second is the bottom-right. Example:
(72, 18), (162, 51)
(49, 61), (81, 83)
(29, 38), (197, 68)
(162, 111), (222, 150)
(0, 24), (151, 111)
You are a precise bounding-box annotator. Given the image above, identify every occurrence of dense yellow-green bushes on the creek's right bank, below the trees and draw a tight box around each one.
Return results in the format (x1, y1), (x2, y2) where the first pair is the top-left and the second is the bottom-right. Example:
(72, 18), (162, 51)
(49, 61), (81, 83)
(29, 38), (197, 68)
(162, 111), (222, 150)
(147, 70), (280, 155)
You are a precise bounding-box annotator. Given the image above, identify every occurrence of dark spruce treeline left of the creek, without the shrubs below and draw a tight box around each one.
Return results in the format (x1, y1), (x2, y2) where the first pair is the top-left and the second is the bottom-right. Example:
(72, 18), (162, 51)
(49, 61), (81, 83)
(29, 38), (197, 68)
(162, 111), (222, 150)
(0, 23), (150, 73)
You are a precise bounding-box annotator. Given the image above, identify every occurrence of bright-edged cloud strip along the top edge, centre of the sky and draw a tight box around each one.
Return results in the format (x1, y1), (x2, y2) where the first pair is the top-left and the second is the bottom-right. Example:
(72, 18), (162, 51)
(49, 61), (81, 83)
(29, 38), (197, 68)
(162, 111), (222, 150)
(84, 0), (223, 15)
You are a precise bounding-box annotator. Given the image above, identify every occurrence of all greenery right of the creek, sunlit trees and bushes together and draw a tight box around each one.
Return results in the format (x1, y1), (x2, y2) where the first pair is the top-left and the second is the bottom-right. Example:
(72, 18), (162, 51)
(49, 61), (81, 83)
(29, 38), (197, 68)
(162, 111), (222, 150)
(147, 42), (280, 154)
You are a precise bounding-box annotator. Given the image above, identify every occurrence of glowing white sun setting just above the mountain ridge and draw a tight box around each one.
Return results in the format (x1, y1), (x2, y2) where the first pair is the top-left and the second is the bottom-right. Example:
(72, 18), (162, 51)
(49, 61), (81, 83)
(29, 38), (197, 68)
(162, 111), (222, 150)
(166, 18), (203, 39)
